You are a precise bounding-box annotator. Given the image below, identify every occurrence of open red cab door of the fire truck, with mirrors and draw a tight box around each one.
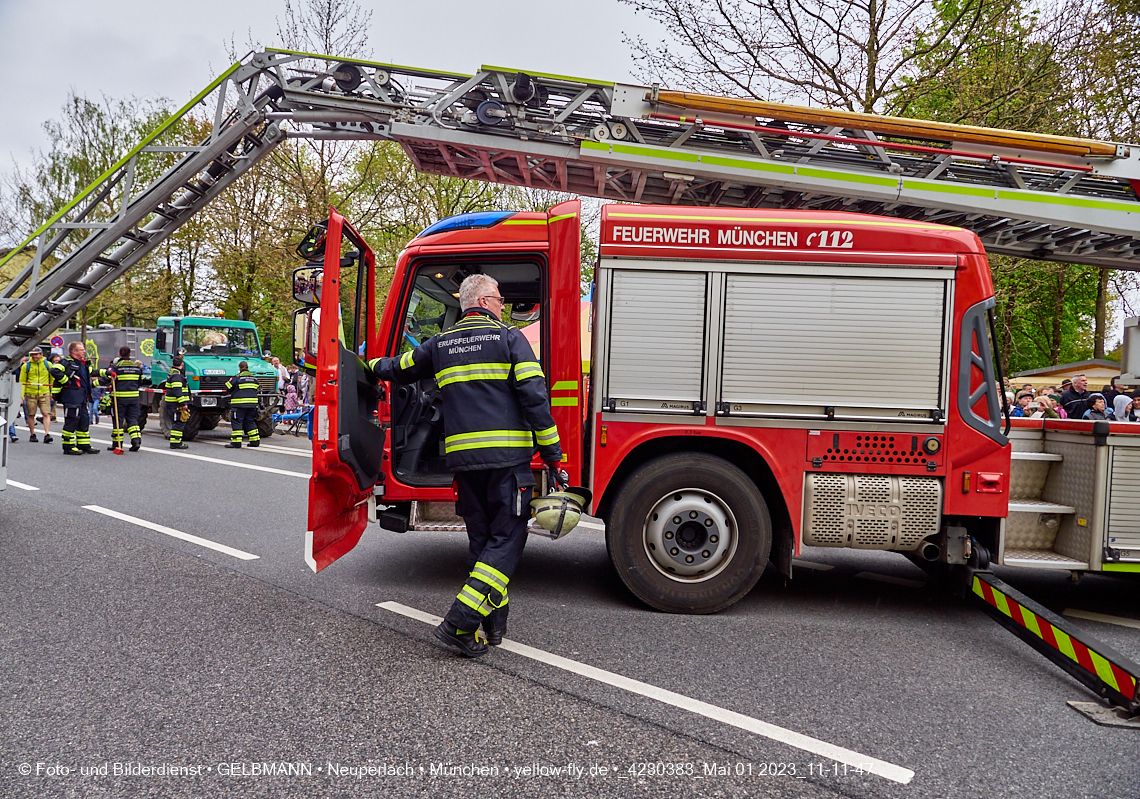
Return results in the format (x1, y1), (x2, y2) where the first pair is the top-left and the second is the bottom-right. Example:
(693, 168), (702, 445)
(302, 210), (384, 571)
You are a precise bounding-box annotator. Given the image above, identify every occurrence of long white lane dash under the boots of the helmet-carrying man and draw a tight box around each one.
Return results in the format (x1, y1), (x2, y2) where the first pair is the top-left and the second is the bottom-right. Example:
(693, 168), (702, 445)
(376, 602), (914, 785)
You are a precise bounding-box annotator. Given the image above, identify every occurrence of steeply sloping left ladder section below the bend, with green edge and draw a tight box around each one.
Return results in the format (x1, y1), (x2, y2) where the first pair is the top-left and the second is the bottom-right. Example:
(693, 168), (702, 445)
(0, 65), (289, 372)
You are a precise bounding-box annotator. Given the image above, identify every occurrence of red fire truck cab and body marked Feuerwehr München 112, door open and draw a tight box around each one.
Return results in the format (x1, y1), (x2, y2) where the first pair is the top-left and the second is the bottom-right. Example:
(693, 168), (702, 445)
(298, 201), (1010, 613)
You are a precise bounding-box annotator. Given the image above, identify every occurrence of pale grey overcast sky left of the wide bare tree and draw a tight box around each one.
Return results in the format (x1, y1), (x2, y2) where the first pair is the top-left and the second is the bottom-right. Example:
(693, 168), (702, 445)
(0, 0), (657, 171)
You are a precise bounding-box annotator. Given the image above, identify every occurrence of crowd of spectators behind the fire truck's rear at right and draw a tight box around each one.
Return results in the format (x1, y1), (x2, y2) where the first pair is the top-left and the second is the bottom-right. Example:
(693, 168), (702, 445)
(1005, 375), (1140, 422)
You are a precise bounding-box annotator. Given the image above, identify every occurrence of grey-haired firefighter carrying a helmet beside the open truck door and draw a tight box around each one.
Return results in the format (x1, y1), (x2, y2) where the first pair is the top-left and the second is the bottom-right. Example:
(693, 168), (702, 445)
(368, 275), (562, 658)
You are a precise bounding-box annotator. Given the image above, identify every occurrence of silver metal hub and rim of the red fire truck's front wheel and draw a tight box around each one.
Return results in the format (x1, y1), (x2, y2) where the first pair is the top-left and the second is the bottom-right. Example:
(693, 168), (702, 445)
(644, 488), (736, 582)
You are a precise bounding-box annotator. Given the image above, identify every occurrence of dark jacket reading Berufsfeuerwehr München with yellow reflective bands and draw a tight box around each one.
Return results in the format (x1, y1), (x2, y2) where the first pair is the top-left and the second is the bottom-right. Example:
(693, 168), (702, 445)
(368, 308), (562, 471)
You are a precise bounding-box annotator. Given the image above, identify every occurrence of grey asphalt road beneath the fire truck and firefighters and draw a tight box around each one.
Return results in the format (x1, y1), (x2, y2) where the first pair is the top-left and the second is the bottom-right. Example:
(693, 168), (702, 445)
(0, 427), (1140, 799)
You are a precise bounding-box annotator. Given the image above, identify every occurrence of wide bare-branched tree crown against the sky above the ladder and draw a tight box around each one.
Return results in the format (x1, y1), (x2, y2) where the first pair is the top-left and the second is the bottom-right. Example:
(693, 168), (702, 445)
(621, 0), (993, 113)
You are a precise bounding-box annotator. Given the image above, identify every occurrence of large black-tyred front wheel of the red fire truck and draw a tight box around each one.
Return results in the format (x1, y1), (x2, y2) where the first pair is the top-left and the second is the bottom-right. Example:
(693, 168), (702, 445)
(605, 453), (772, 613)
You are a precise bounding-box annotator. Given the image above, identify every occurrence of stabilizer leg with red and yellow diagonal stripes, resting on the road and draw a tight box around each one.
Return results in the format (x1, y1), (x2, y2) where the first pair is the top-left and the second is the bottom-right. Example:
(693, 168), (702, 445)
(970, 571), (1140, 725)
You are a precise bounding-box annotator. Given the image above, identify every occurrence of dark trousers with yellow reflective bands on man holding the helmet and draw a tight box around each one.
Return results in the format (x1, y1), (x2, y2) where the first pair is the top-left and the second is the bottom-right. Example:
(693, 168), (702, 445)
(445, 463), (535, 633)
